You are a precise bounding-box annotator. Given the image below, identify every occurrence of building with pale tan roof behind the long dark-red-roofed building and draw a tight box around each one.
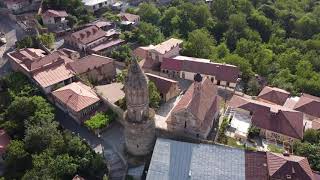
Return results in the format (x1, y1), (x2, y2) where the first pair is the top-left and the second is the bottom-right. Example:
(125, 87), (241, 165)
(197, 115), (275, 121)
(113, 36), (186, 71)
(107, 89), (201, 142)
(133, 38), (182, 70)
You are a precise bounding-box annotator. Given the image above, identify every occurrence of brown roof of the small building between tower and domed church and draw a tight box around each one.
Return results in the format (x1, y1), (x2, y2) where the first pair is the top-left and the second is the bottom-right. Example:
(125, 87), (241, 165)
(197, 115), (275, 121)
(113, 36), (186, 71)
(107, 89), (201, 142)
(145, 73), (178, 95)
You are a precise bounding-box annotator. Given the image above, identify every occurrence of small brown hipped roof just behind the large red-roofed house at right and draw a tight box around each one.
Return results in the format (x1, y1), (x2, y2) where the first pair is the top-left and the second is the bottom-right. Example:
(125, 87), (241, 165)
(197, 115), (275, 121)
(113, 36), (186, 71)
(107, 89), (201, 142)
(258, 86), (290, 105)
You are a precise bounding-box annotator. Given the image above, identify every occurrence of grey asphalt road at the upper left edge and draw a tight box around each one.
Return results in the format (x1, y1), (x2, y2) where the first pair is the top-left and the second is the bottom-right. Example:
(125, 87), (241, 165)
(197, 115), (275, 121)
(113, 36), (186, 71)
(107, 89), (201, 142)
(0, 15), (25, 76)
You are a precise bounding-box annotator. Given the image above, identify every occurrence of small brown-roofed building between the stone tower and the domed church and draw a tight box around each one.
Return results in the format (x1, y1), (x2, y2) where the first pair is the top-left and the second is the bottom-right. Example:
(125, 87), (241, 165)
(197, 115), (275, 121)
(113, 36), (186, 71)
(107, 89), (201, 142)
(146, 73), (180, 102)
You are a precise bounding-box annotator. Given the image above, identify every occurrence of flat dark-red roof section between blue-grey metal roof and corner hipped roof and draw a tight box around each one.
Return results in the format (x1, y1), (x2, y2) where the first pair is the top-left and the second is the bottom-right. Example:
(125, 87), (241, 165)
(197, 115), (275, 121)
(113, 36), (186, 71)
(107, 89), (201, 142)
(245, 151), (269, 180)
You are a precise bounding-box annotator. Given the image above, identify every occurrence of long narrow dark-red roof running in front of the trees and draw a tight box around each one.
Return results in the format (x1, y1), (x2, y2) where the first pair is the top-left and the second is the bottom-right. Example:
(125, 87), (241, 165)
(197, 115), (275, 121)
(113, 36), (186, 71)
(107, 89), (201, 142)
(161, 56), (240, 83)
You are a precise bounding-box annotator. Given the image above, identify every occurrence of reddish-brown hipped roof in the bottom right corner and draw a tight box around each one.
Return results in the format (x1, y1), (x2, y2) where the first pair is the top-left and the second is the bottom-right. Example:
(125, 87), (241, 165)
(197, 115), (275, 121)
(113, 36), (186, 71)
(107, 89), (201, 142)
(267, 152), (313, 180)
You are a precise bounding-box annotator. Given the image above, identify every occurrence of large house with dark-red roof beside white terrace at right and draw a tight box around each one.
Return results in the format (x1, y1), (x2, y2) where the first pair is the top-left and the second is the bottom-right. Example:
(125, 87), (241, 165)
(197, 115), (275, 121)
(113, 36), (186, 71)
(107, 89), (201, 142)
(228, 95), (304, 143)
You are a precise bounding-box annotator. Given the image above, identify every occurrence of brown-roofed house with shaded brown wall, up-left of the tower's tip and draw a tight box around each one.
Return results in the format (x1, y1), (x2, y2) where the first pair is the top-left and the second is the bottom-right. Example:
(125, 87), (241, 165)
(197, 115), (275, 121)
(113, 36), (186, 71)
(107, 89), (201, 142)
(68, 54), (116, 82)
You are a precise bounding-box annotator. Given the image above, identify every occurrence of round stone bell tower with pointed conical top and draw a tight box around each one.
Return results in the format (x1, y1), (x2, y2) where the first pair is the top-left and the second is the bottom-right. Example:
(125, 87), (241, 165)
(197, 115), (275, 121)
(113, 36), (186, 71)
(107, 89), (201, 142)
(124, 59), (155, 156)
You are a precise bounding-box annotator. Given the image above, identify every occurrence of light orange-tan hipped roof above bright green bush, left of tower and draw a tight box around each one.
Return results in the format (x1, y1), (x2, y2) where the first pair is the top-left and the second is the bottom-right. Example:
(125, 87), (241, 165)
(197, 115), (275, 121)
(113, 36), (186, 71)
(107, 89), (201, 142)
(52, 82), (100, 112)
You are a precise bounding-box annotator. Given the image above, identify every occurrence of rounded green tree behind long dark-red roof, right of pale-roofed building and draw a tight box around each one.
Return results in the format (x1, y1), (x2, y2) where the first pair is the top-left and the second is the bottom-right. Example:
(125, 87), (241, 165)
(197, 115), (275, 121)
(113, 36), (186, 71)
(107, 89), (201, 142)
(183, 29), (215, 58)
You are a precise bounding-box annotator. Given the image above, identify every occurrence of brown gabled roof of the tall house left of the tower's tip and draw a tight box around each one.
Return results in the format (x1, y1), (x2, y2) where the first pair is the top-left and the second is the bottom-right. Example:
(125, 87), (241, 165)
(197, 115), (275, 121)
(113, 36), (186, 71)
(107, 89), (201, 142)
(68, 54), (115, 74)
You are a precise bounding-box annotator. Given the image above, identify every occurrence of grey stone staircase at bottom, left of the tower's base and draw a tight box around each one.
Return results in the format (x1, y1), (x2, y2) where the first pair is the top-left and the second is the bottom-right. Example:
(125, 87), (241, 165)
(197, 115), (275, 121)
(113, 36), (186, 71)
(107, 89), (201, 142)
(104, 149), (128, 180)
